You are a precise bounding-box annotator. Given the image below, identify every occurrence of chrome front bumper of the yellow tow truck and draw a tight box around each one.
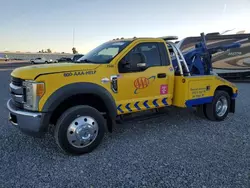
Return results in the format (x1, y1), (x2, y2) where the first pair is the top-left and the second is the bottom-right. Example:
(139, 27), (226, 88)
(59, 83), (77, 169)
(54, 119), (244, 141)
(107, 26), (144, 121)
(7, 99), (43, 137)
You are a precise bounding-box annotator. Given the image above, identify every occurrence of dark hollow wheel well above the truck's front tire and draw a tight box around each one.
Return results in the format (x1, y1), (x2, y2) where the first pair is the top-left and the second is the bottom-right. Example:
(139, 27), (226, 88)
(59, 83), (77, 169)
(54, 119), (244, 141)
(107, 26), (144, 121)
(50, 94), (112, 130)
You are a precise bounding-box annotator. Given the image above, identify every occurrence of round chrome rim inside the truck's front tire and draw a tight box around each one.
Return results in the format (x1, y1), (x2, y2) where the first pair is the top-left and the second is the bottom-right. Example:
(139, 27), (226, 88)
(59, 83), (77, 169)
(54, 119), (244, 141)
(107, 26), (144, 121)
(67, 116), (98, 148)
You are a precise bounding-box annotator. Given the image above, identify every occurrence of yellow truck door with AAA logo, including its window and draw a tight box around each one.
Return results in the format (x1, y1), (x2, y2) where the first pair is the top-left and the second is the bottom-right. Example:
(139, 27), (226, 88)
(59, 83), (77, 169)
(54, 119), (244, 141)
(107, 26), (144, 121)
(116, 42), (174, 114)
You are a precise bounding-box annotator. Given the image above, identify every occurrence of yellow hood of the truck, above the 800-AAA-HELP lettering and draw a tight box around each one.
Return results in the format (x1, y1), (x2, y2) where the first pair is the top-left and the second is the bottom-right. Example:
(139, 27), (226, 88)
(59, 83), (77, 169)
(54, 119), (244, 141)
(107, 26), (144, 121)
(11, 63), (99, 80)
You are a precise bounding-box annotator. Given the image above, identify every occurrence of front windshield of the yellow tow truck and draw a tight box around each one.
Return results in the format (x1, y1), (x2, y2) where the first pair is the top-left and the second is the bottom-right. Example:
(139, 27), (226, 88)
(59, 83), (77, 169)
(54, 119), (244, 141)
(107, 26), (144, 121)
(77, 41), (130, 64)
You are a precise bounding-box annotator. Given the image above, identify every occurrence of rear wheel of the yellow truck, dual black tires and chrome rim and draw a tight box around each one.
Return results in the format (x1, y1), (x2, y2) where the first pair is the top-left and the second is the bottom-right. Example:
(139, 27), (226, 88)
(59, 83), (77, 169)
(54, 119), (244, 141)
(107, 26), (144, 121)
(205, 90), (231, 121)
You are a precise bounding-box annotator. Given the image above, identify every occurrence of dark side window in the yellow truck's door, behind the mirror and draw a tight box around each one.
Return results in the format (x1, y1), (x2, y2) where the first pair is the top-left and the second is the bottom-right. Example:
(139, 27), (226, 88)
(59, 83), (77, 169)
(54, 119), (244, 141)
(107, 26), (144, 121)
(119, 42), (162, 73)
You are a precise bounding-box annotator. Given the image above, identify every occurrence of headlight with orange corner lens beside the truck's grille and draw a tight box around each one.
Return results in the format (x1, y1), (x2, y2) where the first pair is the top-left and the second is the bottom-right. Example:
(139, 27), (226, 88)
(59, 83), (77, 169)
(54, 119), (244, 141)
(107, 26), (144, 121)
(23, 80), (45, 111)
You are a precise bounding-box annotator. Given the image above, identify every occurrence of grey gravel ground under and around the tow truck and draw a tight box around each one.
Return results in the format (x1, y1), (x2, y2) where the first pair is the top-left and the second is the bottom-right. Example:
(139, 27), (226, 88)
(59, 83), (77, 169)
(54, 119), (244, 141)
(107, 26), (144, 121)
(0, 71), (250, 188)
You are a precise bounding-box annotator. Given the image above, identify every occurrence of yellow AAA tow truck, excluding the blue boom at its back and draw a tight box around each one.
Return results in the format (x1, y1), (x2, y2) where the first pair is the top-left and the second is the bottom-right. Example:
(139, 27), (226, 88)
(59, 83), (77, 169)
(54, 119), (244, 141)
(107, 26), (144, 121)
(7, 33), (238, 154)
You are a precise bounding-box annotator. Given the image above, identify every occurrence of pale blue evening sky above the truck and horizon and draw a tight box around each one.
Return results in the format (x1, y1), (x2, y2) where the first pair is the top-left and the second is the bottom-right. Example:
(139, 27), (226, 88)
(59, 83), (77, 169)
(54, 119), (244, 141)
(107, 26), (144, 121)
(0, 0), (250, 53)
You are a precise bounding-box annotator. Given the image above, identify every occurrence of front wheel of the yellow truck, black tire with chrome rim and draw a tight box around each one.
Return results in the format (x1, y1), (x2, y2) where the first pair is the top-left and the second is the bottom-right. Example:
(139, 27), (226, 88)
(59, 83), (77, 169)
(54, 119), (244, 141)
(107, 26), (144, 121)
(54, 105), (105, 155)
